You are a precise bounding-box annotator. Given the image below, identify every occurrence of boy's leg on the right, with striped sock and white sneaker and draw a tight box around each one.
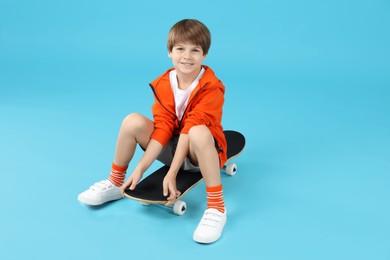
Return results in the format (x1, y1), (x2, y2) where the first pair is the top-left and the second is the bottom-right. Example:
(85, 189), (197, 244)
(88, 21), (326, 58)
(189, 125), (226, 243)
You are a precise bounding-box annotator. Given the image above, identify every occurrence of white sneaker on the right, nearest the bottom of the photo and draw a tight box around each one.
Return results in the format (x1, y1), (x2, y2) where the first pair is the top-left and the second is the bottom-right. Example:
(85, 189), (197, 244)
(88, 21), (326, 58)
(193, 208), (226, 244)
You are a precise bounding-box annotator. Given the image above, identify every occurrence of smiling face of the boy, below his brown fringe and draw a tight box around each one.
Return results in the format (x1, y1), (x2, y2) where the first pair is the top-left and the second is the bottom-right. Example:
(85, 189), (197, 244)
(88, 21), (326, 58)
(168, 43), (206, 76)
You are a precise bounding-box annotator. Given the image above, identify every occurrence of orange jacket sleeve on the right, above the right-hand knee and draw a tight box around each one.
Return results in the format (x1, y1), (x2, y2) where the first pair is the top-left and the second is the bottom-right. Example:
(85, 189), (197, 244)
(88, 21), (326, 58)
(181, 84), (224, 134)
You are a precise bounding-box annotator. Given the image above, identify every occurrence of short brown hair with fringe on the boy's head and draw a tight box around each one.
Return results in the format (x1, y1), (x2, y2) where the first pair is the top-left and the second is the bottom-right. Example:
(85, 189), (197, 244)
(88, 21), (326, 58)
(168, 19), (211, 55)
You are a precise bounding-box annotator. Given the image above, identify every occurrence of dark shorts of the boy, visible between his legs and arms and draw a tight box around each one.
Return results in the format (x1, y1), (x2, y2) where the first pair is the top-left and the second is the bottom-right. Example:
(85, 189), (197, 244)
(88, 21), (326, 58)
(157, 135), (200, 172)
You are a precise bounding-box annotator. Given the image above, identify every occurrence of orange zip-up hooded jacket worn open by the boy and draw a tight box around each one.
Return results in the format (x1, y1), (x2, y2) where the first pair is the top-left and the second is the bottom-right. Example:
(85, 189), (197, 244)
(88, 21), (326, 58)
(150, 66), (227, 167)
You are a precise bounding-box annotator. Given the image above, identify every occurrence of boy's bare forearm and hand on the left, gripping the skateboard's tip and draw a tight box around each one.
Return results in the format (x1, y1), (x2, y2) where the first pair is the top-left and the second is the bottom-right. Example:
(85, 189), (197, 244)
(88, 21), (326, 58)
(121, 139), (163, 195)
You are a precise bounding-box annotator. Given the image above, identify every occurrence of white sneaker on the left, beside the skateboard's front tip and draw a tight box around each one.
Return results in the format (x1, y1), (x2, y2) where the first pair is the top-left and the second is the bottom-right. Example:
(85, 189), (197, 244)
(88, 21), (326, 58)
(78, 180), (122, 206)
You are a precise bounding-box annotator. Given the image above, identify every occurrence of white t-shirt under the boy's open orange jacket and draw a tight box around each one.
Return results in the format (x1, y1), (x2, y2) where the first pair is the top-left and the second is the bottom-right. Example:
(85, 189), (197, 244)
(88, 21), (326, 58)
(169, 68), (205, 120)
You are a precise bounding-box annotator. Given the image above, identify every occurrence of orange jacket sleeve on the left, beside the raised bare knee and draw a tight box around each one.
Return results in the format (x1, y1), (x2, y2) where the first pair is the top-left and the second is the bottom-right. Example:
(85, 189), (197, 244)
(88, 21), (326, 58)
(151, 97), (176, 146)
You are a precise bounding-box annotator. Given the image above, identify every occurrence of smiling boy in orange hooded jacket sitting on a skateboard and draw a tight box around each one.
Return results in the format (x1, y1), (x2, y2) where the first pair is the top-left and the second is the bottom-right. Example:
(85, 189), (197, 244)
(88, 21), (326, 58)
(78, 19), (227, 243)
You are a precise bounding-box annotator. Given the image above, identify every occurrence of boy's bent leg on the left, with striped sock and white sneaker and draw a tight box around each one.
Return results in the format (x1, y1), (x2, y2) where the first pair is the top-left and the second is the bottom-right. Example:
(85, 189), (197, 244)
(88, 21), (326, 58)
(78, 113), (154, 205)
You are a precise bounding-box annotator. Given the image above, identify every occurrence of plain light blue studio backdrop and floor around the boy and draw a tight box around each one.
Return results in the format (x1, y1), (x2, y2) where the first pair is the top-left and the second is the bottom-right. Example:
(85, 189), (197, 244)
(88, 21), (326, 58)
(0, 0), (390, 259)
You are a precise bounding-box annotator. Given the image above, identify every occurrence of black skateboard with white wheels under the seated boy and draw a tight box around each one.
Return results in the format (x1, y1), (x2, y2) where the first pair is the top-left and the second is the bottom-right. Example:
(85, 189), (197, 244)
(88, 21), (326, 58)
(125, 130), (245, 215)
